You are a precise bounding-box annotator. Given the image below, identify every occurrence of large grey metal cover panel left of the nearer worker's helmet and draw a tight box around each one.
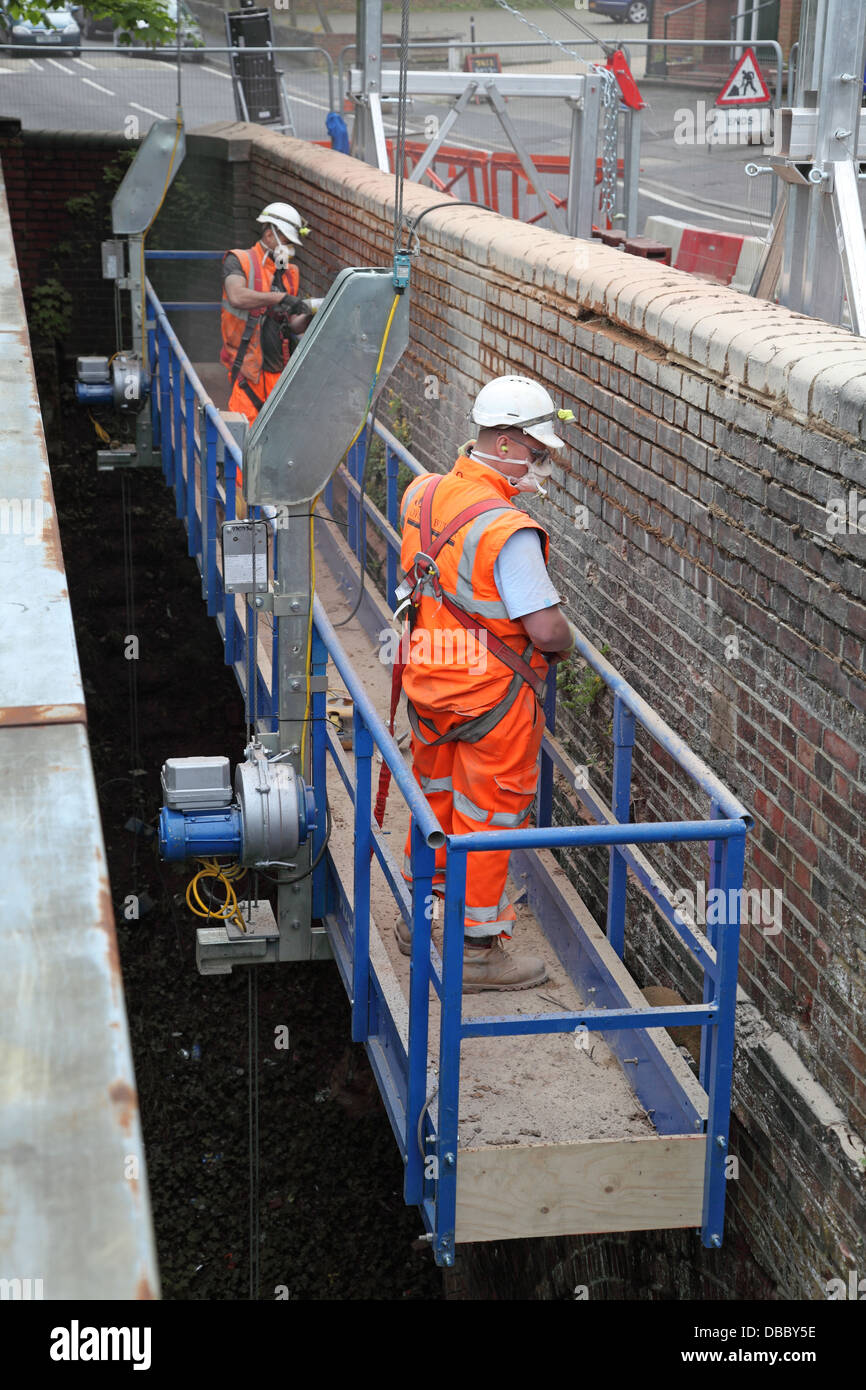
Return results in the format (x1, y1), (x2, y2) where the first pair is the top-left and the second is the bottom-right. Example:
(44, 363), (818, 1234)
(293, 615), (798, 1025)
(243, 268), (409, 506)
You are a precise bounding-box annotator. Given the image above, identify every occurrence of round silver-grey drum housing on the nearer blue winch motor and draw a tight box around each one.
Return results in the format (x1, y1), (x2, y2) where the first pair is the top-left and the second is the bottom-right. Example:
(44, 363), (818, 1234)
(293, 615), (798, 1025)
(235, 749), (303, 865)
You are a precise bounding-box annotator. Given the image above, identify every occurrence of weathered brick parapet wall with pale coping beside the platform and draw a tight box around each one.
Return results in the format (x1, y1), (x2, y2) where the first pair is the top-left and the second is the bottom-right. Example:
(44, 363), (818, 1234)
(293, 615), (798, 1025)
(223, 132), (866, 1297)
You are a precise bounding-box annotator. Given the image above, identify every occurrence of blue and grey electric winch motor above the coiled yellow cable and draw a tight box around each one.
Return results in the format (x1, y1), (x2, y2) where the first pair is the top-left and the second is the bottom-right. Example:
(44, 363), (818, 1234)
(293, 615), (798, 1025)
(160, 744), (316, 867)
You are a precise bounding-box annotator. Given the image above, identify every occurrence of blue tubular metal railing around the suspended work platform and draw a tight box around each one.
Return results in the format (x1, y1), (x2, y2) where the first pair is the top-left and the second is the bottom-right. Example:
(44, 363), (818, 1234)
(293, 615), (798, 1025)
(147, 265), (752, 1265)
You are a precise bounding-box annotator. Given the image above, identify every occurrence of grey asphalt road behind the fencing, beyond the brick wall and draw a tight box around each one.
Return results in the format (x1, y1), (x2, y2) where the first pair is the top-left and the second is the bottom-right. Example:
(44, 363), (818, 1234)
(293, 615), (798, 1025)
(0, 39), (771, 235)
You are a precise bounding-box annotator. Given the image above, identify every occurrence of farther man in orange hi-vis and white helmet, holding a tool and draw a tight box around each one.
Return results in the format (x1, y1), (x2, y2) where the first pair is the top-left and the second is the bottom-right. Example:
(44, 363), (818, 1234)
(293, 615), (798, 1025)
(220, 203), (321, 424)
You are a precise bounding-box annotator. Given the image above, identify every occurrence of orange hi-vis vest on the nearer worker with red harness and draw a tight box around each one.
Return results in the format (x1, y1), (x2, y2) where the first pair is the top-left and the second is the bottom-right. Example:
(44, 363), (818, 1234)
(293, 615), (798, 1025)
(400, 455), (550, 719)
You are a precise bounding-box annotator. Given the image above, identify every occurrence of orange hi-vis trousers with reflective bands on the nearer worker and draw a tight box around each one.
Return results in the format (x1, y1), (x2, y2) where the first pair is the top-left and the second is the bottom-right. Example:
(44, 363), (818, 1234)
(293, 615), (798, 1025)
(403, 685), (545, 937)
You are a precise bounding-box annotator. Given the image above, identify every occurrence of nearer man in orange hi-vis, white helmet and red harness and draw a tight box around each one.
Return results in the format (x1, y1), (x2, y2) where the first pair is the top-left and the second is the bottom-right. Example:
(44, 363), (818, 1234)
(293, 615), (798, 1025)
(395, 377), (574, 994)
